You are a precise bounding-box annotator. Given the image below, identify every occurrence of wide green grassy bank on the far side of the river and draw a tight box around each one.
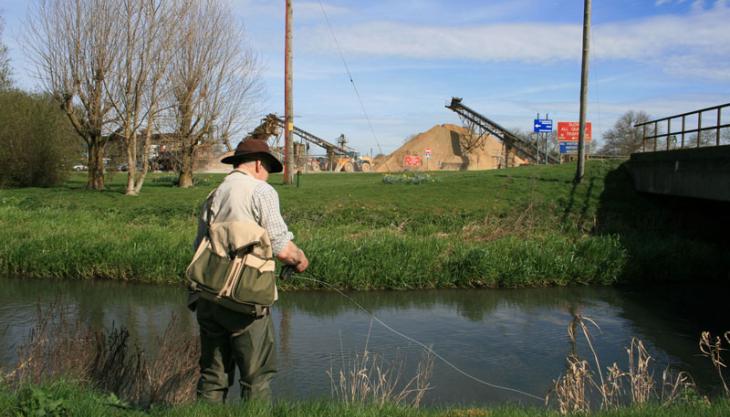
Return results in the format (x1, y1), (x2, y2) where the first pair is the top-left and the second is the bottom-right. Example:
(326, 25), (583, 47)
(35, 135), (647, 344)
(0, 161), (730, 289)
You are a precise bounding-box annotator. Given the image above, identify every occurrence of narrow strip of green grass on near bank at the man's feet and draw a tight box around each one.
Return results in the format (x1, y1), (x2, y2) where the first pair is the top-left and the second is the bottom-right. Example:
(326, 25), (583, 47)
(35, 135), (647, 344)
(0, 381), (730, 417)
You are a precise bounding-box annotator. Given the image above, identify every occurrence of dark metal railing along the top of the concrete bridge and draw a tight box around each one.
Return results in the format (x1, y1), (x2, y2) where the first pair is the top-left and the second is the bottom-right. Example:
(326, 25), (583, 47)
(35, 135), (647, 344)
(634, 103), (730, 152)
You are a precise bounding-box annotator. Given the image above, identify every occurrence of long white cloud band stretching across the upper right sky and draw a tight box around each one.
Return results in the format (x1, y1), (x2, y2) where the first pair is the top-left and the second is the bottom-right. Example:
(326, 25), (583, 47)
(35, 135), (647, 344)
(299, 1), (730, 79)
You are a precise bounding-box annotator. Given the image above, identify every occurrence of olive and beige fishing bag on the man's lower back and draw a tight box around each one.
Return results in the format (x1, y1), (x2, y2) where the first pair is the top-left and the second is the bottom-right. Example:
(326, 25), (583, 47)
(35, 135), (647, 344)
(186, 221), (278, 315)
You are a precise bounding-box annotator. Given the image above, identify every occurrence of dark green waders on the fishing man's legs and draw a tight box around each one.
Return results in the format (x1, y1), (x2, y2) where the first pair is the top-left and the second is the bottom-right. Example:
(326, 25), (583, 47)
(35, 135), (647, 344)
(196, 299), (276, 402)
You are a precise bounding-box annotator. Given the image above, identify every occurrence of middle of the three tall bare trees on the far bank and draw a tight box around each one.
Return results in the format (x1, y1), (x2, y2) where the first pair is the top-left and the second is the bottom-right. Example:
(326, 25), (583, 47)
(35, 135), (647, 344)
(106, 0), (175, 195)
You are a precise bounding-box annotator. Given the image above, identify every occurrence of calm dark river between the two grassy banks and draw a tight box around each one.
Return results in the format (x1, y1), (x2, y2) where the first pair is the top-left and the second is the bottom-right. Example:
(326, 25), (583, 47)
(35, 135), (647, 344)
(0, 278), (730, 405)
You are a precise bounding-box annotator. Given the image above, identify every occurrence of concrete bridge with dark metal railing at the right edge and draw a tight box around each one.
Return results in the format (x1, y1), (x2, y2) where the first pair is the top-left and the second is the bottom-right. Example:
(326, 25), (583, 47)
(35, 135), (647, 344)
(628, 103), (730, 202)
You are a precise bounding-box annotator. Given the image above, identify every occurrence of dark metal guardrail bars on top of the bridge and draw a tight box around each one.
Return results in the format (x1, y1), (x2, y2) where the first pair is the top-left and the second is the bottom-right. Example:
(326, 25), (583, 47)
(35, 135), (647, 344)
(634, 103), (730, 152)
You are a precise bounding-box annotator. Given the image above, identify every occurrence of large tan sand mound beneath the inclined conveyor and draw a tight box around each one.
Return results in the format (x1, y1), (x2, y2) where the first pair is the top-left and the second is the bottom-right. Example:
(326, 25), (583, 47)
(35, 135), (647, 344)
(376, 124), (526, 172)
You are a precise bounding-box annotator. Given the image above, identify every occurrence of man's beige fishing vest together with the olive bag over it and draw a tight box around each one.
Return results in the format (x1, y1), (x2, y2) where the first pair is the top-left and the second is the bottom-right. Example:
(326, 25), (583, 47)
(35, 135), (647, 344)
(186, 171), (278, 316)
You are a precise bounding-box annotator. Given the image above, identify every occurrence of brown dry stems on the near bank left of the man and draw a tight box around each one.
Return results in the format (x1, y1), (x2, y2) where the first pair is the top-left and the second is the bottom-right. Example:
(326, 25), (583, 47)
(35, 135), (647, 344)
(3, 304), (200, 408)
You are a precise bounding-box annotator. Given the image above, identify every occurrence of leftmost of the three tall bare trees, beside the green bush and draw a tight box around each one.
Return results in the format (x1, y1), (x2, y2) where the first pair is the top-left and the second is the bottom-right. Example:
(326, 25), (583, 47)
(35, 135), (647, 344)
(25, 0), (120, 190)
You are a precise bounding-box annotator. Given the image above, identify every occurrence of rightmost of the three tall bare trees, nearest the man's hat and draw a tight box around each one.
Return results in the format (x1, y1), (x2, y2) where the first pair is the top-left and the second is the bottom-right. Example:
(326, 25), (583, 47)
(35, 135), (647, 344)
(168, 0), (259, 187)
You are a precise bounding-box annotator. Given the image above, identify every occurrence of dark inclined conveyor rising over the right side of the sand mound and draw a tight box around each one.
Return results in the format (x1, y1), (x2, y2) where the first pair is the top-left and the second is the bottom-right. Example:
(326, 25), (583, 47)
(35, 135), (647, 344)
(446, 97), (560, 166)
